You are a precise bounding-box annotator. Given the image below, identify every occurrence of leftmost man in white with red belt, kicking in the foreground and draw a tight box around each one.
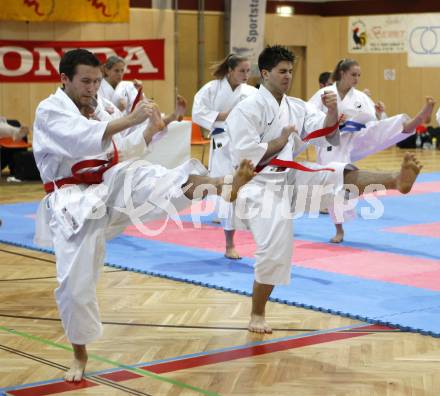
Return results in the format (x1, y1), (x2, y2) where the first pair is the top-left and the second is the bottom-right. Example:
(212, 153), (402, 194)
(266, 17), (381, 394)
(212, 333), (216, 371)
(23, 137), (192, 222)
(33, 49), (253, 381)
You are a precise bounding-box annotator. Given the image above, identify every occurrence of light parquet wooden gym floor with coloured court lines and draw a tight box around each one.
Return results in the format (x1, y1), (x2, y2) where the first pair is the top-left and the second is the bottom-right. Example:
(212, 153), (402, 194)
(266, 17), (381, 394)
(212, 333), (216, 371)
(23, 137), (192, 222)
(0, 148), (440, 396)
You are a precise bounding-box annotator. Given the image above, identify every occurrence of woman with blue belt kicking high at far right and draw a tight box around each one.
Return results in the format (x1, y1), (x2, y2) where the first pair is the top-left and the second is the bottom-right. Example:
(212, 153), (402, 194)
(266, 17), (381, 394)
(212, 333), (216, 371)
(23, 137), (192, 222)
(309, 59), (435, 243)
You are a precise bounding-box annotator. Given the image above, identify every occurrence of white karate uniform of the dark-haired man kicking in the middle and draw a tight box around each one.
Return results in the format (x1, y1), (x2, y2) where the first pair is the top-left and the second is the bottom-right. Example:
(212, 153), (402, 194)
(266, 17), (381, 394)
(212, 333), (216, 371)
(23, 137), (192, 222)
(226, 85), (347, 285)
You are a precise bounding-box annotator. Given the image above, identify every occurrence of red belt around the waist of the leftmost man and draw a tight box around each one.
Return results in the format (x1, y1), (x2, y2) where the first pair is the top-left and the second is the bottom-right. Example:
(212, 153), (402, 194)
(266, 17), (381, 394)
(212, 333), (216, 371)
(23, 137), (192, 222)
(44, 140), (119, 194)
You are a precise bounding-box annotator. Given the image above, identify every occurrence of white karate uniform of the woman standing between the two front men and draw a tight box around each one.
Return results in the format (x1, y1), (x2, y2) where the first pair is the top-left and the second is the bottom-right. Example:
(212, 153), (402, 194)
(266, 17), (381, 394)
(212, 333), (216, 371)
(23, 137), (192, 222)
(192, 77), (257, 230)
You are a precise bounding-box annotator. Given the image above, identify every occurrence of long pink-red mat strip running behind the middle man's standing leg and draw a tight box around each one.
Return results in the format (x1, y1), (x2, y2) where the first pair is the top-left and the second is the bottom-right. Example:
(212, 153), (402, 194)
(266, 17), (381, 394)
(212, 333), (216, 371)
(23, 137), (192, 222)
(124, 221), (440, 291)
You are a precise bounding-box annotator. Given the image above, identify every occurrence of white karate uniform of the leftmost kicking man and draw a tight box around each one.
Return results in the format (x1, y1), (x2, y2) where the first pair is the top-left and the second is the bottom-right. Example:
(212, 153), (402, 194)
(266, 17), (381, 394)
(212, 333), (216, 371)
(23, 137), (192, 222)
(33, 89), (207, 345)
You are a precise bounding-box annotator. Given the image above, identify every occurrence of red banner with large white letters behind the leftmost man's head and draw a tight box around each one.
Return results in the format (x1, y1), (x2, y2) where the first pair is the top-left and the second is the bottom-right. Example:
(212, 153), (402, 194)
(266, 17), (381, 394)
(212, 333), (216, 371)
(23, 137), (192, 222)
(0, 39), (165, 82)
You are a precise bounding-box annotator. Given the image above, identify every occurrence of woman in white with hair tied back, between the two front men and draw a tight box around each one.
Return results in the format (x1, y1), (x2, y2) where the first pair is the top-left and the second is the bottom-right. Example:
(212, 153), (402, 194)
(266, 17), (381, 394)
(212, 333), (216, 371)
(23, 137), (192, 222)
(192, 54), (257, 259)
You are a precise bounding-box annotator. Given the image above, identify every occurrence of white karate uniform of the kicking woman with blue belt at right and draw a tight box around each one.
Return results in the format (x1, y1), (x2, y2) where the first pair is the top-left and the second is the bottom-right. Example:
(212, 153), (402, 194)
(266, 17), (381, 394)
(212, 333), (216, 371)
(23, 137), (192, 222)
(309, 83), (415, 224)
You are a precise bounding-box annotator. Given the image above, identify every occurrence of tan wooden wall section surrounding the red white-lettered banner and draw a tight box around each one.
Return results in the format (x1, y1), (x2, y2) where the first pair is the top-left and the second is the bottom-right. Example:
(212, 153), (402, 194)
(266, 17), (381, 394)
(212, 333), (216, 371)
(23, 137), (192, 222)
(0, 9), (174, 125)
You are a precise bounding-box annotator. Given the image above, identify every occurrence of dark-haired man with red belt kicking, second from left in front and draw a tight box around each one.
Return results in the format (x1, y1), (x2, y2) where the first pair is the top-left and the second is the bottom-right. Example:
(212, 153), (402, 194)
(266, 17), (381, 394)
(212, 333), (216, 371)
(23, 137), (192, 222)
(226, 46), (421, 333)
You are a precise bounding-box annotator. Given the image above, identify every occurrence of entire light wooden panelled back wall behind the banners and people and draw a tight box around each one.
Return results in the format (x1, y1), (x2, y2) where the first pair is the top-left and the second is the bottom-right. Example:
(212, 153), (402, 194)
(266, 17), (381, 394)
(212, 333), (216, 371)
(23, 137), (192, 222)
(0, 8), (440, 125)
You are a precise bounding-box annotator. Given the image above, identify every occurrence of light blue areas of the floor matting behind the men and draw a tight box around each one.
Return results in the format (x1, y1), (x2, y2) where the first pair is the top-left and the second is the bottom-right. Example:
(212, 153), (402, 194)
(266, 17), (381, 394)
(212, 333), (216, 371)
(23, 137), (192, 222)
(0, 173), (440, 336)
